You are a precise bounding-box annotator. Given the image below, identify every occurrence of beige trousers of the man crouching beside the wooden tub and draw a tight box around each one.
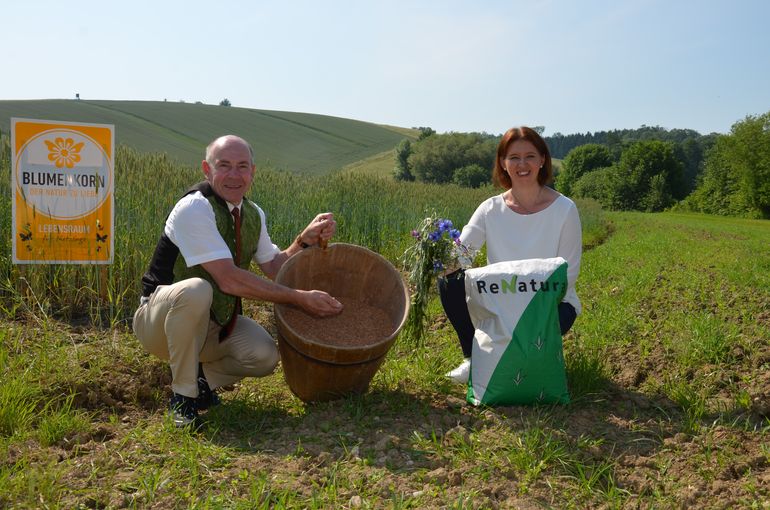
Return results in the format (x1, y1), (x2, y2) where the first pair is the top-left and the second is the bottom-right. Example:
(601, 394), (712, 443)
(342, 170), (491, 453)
(133, 278), (279, 397)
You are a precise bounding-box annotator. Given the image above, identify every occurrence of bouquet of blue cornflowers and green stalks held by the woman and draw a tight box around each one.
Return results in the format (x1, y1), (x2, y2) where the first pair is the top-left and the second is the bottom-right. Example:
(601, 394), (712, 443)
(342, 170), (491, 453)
(403, 215), (473, 345)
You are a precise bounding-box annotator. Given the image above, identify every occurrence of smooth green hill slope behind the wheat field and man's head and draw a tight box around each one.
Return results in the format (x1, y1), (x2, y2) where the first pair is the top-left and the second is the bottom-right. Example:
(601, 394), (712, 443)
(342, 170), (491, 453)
(0, 99), (410, 173)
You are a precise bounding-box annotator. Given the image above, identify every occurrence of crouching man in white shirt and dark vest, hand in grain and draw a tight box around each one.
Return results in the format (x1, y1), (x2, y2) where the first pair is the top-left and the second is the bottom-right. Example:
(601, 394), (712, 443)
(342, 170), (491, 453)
(133, 135), (342, 427)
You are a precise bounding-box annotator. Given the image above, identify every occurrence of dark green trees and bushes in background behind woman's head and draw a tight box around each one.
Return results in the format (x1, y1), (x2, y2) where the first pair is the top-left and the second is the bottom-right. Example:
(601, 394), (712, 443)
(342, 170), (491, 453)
(394, 112), (770, 218)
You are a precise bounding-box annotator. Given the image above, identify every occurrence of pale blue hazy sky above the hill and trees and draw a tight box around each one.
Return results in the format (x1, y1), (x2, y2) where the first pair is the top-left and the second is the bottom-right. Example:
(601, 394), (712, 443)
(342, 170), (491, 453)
(0, 0), (770, 135)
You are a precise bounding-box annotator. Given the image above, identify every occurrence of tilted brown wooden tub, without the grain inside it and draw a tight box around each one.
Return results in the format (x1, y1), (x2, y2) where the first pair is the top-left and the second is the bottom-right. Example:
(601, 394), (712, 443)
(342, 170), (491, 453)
(275, 243), (409, 402)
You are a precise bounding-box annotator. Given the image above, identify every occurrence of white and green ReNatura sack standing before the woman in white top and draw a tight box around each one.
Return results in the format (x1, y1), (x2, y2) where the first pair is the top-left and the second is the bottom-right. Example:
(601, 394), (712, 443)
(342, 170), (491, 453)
(465, 257), (569, 405)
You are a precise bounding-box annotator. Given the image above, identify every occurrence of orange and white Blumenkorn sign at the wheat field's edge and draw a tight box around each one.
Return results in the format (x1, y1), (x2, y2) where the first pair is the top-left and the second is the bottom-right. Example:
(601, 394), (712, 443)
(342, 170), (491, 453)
(11, 118), (115, 264)
